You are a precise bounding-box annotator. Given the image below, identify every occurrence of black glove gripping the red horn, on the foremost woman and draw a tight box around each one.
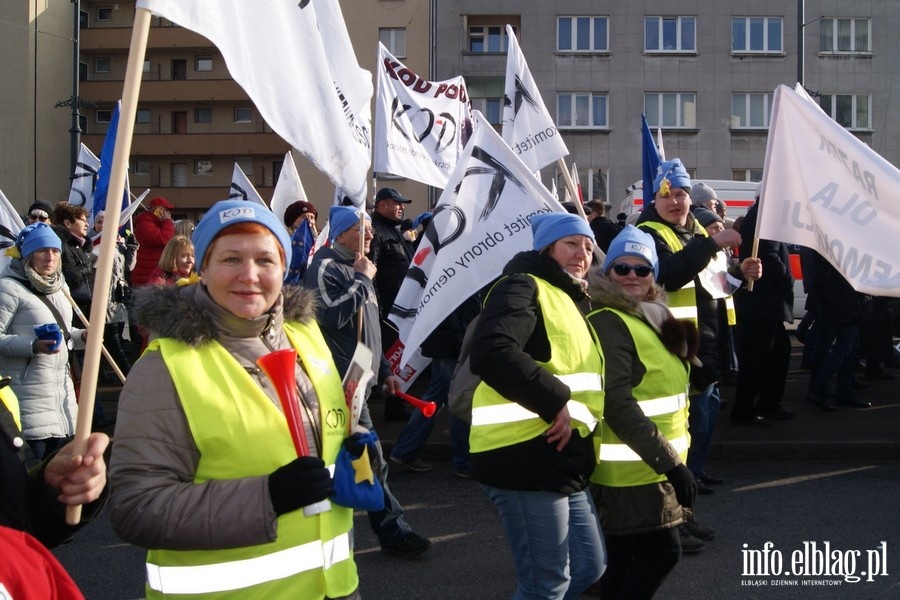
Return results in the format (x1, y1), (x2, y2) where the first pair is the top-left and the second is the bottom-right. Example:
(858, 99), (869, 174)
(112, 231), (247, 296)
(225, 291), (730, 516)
(269, 456), (331, 515)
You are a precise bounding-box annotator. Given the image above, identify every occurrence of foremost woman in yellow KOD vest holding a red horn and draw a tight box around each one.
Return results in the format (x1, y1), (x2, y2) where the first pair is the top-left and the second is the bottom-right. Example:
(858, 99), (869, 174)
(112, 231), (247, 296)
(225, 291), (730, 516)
(110, 200), (358, 599)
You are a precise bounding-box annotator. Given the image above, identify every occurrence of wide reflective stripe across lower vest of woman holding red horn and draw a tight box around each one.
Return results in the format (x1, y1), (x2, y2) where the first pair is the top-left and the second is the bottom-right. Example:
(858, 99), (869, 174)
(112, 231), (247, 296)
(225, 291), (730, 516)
(147, 533), (351, 594)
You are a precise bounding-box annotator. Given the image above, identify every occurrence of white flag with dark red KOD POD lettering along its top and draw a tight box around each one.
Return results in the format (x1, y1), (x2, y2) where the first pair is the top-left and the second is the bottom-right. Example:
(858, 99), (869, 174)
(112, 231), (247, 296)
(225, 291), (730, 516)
(373, 42), (472, 188)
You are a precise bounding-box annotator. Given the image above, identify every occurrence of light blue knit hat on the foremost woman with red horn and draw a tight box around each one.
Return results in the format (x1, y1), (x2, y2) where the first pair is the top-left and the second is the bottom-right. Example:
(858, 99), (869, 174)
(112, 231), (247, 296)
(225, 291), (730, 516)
(191, 200), (291, 273)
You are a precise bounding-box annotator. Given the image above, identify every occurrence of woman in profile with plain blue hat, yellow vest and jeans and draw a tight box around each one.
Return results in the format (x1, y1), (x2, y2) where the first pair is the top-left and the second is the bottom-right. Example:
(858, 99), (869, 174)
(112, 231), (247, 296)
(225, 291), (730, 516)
(469, 213), (606, 600)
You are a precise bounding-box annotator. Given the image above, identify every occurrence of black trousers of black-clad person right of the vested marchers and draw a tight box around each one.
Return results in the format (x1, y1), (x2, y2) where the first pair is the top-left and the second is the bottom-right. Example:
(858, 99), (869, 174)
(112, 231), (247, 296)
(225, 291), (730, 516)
(731, 319), (791, 420)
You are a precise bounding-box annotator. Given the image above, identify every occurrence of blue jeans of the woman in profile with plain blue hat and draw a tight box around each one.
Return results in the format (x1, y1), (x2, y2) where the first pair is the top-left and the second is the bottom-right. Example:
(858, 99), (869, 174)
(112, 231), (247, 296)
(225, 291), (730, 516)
(482, 485), (606, 600)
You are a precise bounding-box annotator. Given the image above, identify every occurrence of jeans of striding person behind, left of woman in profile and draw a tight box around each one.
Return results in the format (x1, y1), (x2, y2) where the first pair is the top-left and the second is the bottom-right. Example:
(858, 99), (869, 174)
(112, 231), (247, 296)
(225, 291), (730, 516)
(391, 358), (469, 472)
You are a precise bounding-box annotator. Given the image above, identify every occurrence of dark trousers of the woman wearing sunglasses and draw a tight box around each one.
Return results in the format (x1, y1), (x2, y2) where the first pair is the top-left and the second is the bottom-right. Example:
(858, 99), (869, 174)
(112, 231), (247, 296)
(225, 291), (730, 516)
(600, 527), (681, 600)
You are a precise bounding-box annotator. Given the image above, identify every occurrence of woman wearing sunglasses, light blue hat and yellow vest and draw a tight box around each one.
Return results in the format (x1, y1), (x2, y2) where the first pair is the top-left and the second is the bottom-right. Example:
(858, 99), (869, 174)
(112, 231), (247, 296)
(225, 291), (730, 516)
(588, 225), (698, 599)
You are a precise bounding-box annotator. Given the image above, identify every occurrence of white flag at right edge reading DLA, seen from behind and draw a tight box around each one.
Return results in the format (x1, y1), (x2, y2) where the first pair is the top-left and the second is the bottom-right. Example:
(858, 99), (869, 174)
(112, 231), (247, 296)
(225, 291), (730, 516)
(758, 85), (900, 297)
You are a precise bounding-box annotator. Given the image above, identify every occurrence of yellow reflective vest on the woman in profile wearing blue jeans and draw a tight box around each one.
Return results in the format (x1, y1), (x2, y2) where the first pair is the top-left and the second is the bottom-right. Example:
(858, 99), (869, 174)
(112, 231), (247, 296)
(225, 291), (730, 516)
(469, 275), (603, 452)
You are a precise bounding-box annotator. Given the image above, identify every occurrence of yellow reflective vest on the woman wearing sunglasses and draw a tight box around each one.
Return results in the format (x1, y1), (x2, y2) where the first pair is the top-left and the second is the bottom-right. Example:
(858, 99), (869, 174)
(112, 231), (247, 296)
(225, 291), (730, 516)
(591, 308), (690, 487)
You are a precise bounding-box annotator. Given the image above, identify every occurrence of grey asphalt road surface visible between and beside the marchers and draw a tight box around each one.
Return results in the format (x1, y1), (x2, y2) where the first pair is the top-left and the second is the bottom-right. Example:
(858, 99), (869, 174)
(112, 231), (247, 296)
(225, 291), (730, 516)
(54, 460), (900, 600)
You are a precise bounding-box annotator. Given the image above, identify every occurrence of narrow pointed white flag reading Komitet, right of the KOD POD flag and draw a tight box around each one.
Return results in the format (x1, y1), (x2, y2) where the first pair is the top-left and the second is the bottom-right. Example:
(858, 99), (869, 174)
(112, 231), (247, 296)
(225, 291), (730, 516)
(503, 25), (569, 171)
